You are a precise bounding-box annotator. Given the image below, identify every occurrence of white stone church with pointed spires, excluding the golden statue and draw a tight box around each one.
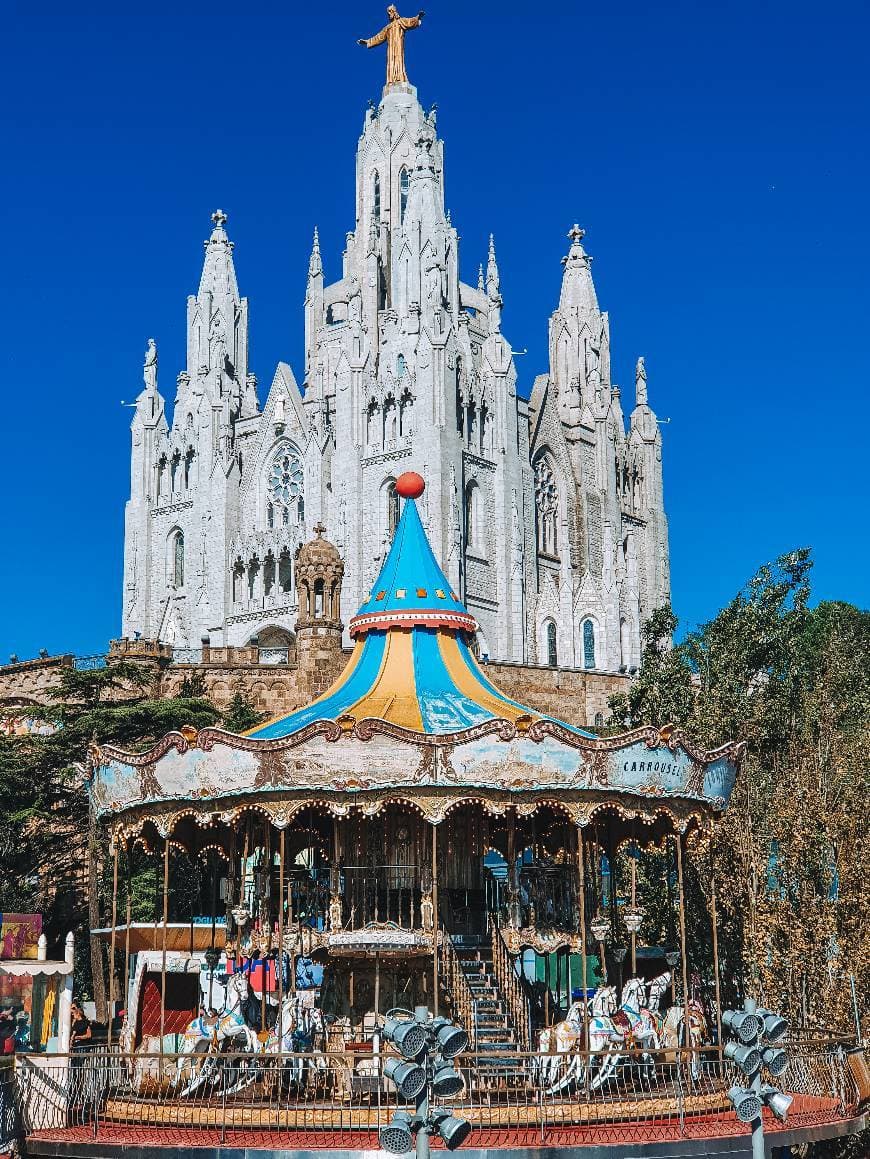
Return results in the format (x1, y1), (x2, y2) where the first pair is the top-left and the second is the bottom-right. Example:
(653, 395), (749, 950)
(122, 72), (670, 672)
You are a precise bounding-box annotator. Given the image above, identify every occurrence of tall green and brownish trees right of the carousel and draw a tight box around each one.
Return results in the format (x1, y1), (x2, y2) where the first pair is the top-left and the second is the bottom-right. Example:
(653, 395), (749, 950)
(611, 549), (870, 1034)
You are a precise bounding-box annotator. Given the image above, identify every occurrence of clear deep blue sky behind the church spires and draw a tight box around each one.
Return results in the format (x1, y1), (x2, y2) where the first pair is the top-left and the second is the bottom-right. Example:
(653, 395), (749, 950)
(0, 0), (870, 658)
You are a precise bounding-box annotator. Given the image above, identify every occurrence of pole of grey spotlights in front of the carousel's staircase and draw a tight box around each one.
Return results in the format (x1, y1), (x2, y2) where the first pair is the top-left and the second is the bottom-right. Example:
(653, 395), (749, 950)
(378, 1006), (471, 1159)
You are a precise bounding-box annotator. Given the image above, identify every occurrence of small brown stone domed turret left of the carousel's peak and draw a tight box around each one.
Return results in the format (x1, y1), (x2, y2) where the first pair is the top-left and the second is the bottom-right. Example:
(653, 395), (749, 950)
(295, 523), (344, 695)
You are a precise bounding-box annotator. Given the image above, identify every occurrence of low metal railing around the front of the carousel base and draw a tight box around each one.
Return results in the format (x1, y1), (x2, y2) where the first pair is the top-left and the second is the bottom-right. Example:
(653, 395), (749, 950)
(15, 1043), (858, 1150)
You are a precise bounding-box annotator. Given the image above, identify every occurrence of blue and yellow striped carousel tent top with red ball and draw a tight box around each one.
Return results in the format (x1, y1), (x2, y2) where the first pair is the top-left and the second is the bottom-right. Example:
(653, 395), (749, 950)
(247, 472), (592, 741)
